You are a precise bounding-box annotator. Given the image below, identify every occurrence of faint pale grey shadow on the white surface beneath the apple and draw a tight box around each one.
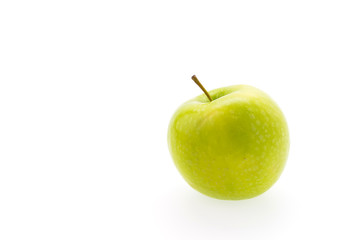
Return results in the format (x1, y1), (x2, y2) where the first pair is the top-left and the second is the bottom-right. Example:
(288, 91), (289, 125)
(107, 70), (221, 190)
(157, 188), (290, 237)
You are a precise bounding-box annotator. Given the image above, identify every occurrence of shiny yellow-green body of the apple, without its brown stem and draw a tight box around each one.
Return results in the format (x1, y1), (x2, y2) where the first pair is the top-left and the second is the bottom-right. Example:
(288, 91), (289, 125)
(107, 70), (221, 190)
(168, 85), (290, 200)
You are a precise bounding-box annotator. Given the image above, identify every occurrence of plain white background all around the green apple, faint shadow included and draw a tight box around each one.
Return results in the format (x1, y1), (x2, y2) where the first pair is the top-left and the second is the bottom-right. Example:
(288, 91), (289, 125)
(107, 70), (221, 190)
(0, 0), (360, 240)
